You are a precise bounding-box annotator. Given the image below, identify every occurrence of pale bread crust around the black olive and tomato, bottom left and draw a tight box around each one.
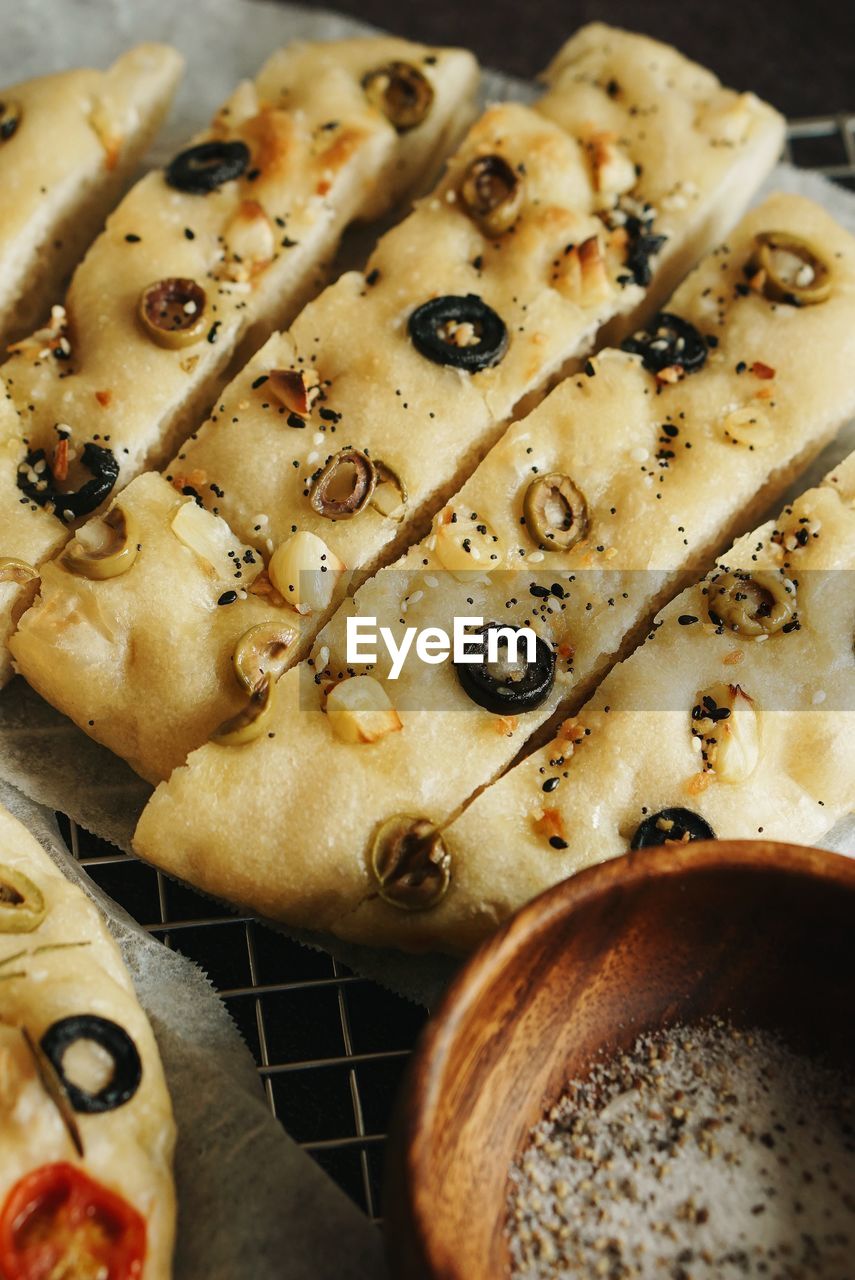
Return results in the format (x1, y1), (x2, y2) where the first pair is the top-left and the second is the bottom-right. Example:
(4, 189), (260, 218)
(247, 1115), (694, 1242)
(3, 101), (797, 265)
(0, 806), (175, 1280)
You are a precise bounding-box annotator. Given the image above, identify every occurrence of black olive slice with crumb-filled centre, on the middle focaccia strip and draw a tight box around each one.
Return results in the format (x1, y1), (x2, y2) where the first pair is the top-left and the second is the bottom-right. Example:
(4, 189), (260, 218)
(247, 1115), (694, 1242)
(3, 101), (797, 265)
(408, 293), (508, 374)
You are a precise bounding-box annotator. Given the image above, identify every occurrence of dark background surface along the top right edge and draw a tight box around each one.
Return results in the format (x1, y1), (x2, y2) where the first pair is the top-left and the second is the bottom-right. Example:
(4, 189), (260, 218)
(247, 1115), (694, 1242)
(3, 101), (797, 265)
(290, 0), (855, 118)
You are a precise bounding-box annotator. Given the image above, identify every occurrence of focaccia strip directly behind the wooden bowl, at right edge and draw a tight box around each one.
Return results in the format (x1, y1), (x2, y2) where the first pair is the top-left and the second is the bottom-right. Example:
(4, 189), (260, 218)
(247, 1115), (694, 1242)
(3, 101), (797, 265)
(407, 457), (855, 951)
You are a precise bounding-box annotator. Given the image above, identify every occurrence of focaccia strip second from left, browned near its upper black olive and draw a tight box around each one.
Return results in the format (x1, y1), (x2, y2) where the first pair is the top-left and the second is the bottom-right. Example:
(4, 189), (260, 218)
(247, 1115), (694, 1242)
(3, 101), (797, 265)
(0, 37), (477, 619)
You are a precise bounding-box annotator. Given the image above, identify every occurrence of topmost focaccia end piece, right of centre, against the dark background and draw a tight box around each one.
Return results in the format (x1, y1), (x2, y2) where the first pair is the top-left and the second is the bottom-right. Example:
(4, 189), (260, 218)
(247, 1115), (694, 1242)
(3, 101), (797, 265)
(538, 22), (782, 343)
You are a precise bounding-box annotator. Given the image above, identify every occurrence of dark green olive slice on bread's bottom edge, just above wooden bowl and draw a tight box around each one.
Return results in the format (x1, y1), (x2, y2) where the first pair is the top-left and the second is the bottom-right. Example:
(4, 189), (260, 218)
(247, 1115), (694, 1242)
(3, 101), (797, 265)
(371, 814), (452, 911)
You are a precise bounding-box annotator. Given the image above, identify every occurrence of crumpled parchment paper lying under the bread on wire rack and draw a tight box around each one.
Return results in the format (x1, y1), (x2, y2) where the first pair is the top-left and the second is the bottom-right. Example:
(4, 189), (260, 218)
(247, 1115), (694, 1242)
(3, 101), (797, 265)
(0, 0), (855, 1280)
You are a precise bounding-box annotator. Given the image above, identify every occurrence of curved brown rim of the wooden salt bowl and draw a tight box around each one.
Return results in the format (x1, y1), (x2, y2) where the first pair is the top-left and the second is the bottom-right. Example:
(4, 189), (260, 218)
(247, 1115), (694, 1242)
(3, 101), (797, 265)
(394, 840), (855, 1274)
